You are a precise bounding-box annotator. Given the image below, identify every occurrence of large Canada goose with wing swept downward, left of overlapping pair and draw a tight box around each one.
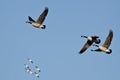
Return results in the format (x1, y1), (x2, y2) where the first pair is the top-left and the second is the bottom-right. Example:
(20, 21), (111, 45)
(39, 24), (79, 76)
(79, 36), (101, 54)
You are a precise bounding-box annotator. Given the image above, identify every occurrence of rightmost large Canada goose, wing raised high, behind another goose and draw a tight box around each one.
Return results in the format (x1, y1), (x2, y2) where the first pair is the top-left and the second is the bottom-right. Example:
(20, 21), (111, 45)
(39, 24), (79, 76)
(91, 30), (113, 54)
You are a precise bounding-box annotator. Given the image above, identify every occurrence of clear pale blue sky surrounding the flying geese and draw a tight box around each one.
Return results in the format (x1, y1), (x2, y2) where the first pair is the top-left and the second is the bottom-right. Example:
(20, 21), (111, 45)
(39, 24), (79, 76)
(0, 0), (120, 80)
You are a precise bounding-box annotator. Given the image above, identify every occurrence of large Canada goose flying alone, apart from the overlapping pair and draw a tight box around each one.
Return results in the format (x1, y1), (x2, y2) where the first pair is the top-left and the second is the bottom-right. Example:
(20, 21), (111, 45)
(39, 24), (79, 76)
(26, 7), (48, 29)
